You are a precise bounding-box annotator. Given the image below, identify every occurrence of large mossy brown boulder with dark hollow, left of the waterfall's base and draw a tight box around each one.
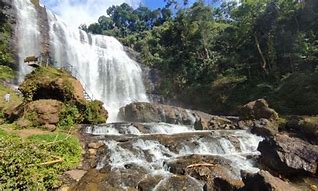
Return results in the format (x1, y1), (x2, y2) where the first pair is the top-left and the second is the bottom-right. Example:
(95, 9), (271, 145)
(6, 67), (108, 131)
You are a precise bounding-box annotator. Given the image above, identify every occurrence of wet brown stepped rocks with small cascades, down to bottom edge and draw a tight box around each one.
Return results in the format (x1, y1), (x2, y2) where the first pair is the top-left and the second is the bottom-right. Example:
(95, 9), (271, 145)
(76, 123), (261, 191)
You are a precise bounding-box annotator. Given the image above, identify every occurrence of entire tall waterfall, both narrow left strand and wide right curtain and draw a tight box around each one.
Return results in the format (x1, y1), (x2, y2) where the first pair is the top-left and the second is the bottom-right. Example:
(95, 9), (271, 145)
(15, 0), (148, 121)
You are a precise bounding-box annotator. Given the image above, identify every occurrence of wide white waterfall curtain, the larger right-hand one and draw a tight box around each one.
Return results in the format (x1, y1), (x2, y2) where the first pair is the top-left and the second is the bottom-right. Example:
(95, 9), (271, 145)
(49, 13), (148, 121)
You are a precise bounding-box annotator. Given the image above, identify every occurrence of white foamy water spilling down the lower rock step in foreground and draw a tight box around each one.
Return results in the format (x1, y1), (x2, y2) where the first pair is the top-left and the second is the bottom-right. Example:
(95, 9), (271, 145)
(94, 124), (262, 178)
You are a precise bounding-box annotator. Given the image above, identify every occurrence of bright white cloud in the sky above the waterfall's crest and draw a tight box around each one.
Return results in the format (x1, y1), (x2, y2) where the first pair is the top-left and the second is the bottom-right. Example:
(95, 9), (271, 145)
(41, 0), (142, 27)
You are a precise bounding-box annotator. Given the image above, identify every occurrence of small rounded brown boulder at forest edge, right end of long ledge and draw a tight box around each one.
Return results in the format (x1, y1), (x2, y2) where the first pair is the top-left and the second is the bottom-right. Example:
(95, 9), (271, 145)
(240, 99), (278, 120)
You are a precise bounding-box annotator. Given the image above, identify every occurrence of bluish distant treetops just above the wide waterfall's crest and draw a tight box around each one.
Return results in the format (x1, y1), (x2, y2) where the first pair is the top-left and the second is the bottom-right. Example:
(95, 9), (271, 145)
(85, 3), (172, 42)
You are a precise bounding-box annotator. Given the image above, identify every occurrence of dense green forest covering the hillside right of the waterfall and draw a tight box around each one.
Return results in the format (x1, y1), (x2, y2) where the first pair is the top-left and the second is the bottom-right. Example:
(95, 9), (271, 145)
(88, 0), (318, 114)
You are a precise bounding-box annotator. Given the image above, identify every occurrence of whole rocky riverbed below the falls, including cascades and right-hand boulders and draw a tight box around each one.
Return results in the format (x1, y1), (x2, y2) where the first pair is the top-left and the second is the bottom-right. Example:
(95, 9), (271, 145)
(62, 100), (318, 191)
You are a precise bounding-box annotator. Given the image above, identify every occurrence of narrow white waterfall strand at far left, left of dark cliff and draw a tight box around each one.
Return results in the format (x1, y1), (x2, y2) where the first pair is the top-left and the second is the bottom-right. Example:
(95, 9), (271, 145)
(13, 0), (41, 83)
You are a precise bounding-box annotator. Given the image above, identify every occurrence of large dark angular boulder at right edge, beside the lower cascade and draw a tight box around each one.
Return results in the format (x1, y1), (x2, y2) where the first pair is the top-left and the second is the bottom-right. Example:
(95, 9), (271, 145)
(258, 134), (318, 176)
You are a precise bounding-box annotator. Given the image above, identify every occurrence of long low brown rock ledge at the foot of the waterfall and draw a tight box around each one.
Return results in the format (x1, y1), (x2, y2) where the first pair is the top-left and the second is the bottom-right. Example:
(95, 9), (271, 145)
(119, 102), (239, 130)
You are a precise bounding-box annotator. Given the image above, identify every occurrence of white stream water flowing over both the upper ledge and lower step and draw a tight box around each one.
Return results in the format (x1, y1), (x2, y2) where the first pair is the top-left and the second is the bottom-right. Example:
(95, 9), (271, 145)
(85, 123), (262, 190)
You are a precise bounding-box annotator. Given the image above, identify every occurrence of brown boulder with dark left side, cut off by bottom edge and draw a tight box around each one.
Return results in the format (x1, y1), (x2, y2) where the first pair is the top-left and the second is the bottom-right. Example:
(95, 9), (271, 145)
(242, 170), (300, 191)
